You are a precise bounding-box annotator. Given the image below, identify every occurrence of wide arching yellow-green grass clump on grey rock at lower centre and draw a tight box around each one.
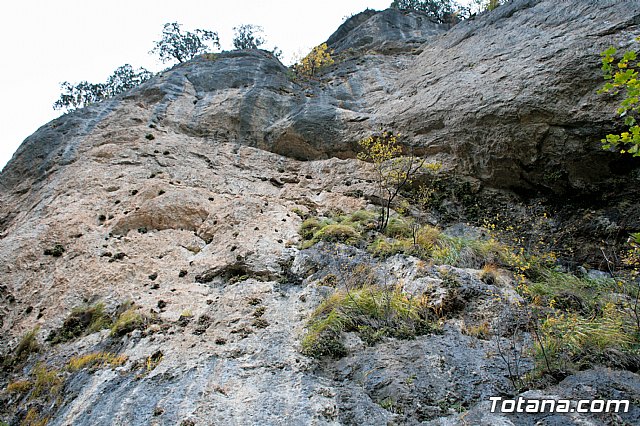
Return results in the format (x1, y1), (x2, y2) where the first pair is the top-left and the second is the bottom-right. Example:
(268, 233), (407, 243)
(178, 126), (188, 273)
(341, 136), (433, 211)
(302, 285), (435, 358)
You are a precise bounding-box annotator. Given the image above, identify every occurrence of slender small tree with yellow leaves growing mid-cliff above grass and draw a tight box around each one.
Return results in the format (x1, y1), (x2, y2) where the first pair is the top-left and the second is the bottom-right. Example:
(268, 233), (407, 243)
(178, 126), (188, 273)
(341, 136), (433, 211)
(358, 131), (432, 232)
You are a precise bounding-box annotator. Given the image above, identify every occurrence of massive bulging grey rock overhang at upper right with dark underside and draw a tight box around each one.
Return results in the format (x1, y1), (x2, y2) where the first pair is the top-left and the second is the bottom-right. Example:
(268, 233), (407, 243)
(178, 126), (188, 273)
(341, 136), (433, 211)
(384, 0), (640, 192)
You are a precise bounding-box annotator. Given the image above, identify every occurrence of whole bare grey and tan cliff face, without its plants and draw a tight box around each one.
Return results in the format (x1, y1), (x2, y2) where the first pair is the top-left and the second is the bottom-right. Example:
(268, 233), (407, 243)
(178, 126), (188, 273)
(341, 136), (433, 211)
(0, 0), (640, 425)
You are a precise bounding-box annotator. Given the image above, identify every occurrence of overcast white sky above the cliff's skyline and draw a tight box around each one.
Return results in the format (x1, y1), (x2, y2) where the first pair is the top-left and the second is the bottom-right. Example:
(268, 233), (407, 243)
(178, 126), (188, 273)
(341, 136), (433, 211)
(0, 0), (391, 169)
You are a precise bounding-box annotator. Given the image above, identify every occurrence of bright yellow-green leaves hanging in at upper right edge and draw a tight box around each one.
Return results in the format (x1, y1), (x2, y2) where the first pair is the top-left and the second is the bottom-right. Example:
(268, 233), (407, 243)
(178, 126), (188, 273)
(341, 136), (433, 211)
(598, 37), (640, 157)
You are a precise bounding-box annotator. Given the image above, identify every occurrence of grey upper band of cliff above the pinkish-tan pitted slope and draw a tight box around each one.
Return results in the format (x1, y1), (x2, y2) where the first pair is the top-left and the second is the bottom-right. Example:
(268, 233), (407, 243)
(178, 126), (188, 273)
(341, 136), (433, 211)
(3, 0), (640, 193)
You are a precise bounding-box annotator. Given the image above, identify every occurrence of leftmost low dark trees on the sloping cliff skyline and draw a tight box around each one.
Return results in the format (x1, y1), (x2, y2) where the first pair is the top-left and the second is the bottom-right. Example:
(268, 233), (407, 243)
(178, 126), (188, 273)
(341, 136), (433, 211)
(53, 64), (153, 111)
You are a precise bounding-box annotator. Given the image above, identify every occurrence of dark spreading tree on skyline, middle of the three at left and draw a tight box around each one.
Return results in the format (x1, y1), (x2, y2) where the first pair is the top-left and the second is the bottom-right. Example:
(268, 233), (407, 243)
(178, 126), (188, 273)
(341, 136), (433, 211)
(149, 22), (220, 63)
